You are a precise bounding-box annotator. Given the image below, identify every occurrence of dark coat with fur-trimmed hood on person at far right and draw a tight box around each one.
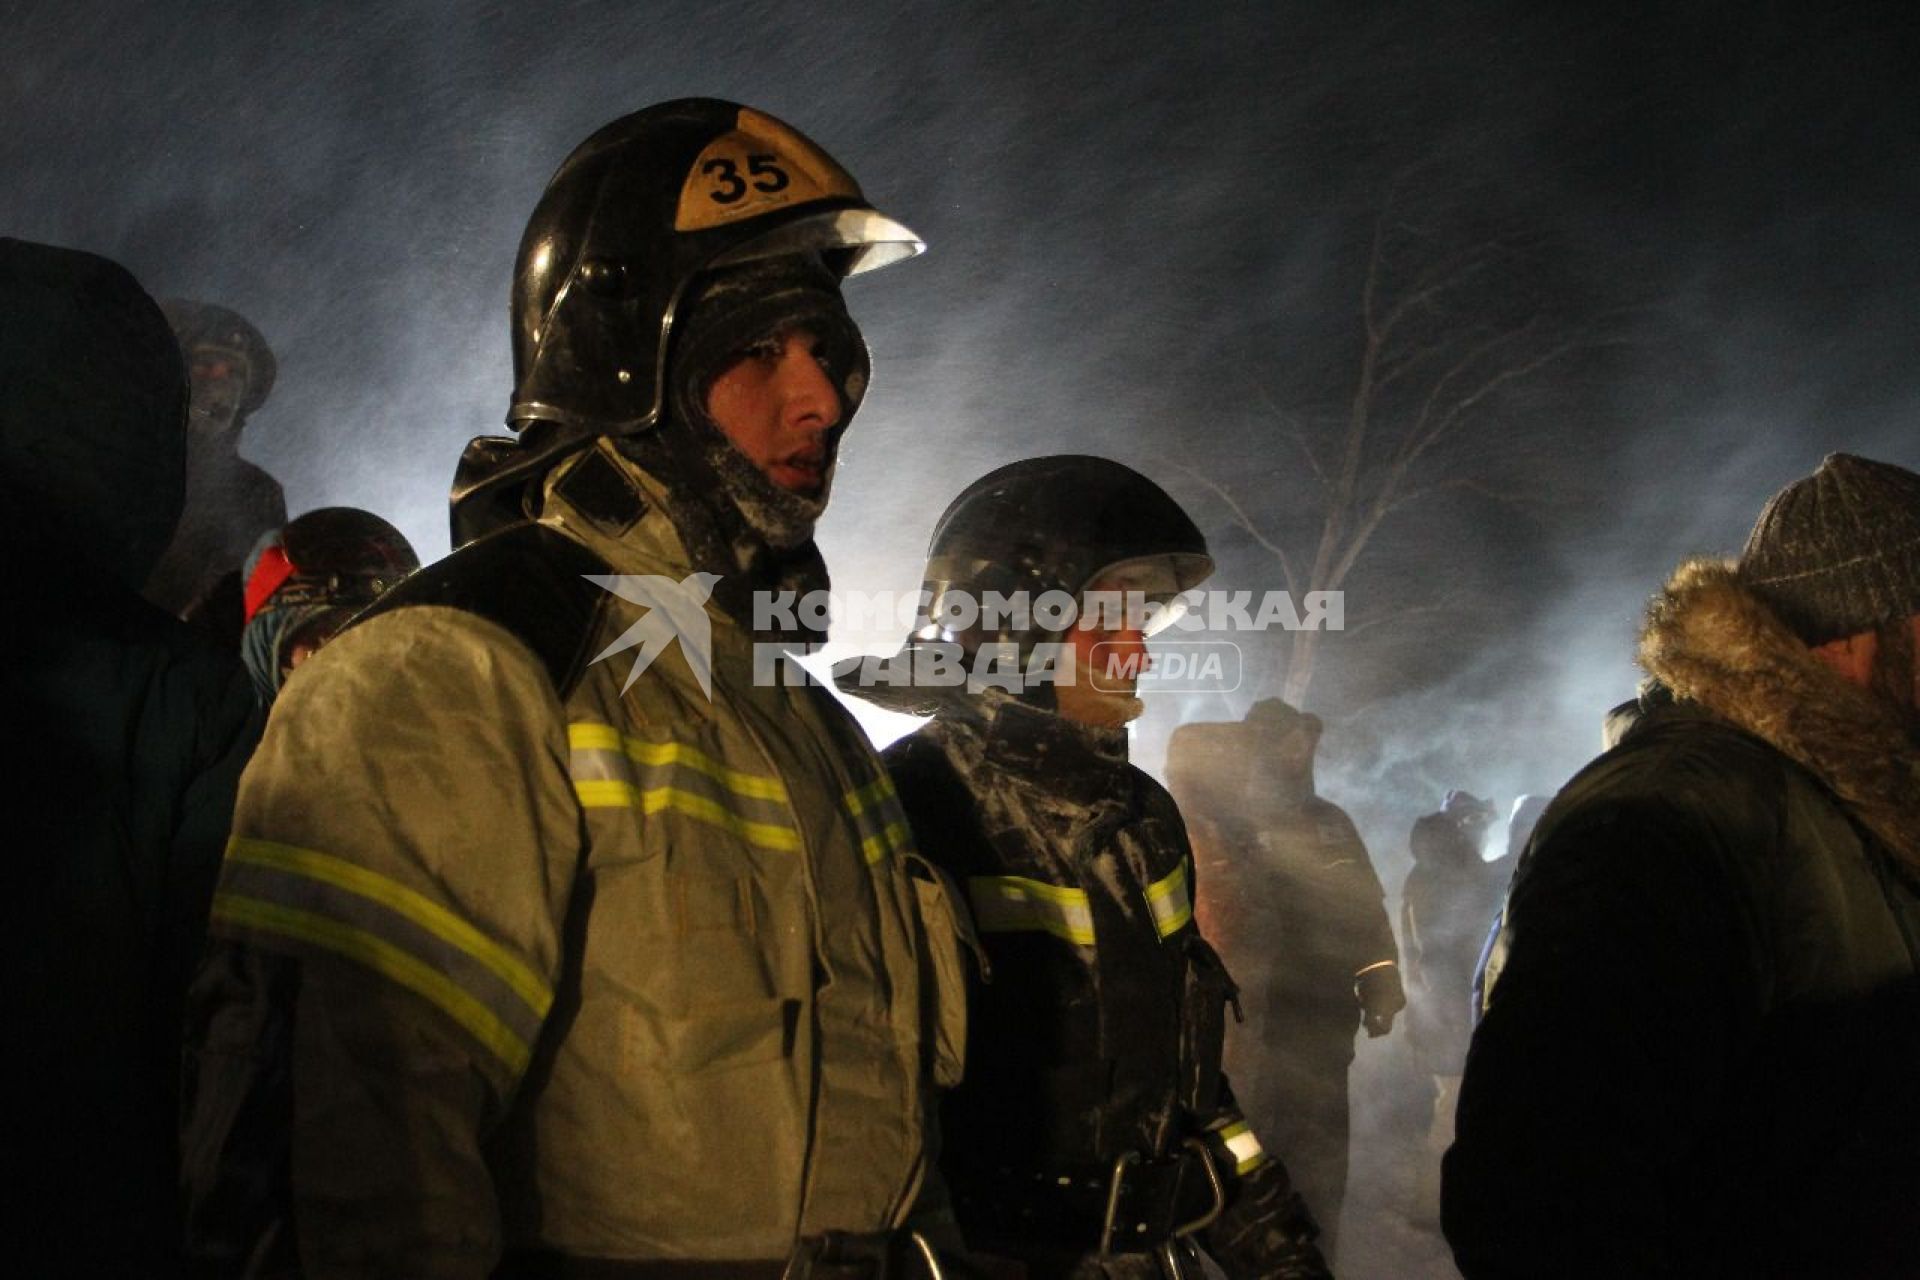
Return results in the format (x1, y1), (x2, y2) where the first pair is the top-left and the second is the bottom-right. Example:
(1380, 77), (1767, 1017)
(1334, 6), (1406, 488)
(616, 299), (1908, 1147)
(1444, 564), (1920, 1280)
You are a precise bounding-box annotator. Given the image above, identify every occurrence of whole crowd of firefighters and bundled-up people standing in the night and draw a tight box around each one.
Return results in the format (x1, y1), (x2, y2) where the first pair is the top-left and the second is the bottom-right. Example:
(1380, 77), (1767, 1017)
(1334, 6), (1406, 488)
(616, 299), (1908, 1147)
(0, 100), (1920, 1280)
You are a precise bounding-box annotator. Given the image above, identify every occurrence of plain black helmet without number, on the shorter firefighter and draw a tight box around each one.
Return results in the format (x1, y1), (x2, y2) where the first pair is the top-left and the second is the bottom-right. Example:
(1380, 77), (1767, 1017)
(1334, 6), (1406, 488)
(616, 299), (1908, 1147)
(835, 453), (1213, 714)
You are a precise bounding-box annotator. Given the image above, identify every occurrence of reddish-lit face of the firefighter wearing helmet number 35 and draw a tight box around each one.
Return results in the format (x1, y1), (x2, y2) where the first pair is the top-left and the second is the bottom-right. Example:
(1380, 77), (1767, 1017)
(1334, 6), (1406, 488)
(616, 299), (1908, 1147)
(707, 328), (841, 497)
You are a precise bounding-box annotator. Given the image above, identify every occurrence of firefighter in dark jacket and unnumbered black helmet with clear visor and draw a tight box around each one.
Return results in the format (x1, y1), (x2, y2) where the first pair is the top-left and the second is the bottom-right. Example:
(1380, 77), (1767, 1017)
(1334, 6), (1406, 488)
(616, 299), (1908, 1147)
(839, 457), (1327, 1278)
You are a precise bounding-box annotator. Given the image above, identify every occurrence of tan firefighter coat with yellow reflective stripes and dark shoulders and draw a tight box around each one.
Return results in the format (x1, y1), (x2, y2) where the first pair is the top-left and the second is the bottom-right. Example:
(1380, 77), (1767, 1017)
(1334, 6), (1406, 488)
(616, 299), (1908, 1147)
(188, 443), (964, 1278)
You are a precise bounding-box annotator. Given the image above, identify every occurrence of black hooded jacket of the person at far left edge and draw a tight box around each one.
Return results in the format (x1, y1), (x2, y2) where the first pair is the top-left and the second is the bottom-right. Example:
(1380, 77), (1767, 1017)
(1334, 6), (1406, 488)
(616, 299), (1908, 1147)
(0, 240), (257, 1276)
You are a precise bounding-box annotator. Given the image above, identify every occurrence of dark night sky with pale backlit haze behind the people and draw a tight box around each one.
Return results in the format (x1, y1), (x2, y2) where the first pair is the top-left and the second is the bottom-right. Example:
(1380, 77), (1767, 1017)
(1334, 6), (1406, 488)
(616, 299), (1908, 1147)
(0, 0), (1920, 1274)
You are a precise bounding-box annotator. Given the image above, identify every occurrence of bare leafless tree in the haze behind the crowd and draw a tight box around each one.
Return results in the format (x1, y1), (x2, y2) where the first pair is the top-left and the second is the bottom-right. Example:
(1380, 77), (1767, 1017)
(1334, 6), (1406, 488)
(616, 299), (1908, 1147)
(1187, 173), (1626, 704)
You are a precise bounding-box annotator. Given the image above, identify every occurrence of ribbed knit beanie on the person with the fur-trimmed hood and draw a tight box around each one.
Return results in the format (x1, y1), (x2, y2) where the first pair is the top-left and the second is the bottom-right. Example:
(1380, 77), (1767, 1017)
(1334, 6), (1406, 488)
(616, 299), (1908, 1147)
(1740, 453), (1920, 645)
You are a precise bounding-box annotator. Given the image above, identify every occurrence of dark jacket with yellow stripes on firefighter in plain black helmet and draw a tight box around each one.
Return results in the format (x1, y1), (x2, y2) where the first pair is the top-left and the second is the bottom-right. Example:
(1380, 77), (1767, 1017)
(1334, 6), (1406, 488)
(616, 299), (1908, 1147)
(885, 695), (1321, 1276)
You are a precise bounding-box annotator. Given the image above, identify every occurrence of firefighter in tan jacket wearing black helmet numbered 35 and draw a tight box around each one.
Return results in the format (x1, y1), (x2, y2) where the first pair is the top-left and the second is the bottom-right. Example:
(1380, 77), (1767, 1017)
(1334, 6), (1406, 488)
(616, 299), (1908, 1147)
(188, 100), (964, 1280)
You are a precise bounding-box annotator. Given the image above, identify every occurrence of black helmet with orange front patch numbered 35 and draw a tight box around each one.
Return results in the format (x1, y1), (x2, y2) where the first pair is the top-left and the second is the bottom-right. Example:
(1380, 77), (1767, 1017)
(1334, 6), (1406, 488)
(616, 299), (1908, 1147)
(453, 98), (925, 545)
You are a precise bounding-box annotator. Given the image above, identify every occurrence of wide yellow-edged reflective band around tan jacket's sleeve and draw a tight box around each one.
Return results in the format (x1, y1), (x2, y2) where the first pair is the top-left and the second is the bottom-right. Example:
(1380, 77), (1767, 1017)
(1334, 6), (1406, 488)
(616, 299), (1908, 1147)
(213, 837), (553, 1077)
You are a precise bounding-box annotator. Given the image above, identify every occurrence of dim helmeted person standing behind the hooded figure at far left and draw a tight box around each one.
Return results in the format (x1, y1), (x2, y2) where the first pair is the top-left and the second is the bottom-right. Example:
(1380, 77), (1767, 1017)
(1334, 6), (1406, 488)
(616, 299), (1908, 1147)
(144, 297), (286, 621)
